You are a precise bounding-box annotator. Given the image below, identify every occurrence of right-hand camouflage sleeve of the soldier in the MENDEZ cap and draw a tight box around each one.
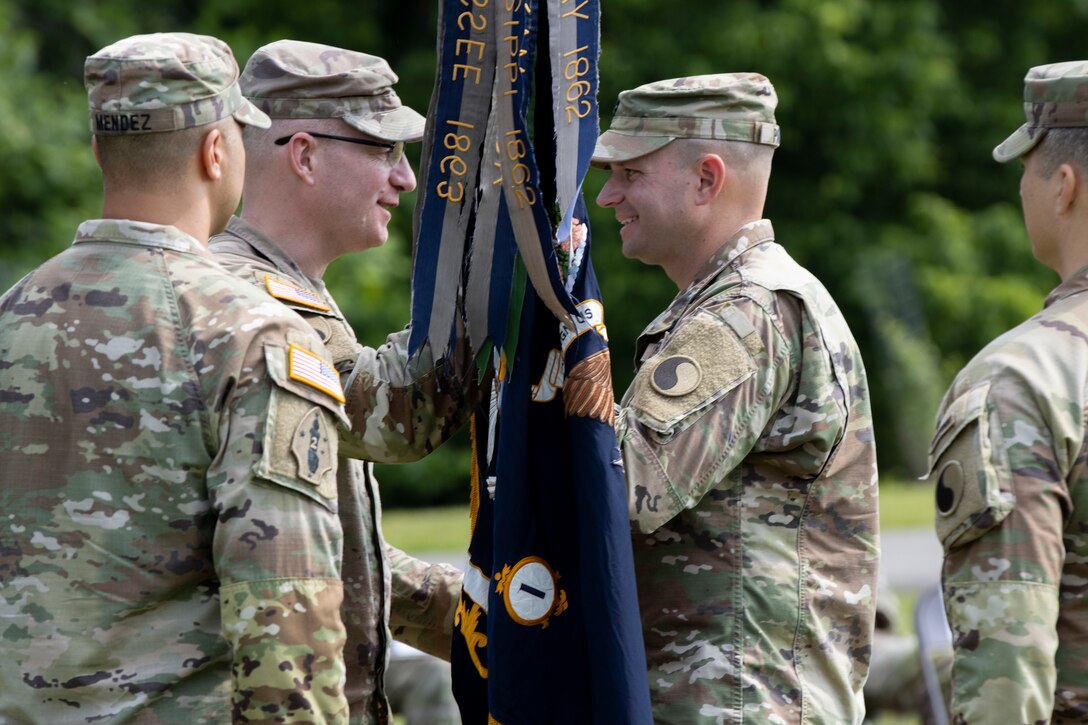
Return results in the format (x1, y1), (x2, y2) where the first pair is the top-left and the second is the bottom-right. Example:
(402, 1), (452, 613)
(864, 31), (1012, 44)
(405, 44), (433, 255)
(208, 335), (348, 723)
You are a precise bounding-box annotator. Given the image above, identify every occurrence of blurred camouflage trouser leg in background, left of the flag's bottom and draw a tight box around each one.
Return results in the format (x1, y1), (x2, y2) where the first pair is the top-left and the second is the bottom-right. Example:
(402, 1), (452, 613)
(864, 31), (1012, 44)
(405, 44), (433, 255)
(385, 648), (461, 725)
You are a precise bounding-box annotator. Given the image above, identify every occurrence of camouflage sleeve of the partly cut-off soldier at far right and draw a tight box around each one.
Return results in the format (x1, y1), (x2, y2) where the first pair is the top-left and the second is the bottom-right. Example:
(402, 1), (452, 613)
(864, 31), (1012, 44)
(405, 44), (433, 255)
(929, 378), (1066, 723)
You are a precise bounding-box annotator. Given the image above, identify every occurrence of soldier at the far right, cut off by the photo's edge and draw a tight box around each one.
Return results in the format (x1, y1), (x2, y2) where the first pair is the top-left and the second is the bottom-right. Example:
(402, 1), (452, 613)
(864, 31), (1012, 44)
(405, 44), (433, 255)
(929, 61), (1088, 724)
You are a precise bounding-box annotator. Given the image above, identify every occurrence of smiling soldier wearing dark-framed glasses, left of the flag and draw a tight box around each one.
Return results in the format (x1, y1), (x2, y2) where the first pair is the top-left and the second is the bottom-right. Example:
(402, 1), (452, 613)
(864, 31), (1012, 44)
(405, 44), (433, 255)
(211, 40), (474, 722)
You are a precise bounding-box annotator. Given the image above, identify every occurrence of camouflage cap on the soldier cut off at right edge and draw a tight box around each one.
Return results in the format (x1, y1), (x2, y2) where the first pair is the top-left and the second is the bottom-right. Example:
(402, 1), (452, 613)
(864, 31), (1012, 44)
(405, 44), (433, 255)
(993, 61), (1088, 163)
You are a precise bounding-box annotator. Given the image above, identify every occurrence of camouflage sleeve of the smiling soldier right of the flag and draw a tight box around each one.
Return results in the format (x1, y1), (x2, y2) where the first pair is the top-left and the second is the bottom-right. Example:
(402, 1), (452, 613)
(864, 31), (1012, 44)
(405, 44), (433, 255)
(617, 299), (798, 533)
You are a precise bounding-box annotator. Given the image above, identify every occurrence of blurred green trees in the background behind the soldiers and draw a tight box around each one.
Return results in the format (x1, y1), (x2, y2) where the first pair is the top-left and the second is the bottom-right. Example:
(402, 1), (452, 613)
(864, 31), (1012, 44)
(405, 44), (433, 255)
(0, 0), (1088, 505)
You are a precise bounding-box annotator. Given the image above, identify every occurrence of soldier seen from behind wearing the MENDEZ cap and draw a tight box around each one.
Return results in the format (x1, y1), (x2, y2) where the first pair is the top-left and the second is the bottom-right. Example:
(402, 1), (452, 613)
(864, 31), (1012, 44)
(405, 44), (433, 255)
(0, 34), (348, 725)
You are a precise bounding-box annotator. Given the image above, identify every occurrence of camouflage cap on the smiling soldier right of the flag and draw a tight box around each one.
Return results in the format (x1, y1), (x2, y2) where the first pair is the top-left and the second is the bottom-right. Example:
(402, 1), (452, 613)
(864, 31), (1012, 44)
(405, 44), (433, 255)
(593, 73), (781, 165)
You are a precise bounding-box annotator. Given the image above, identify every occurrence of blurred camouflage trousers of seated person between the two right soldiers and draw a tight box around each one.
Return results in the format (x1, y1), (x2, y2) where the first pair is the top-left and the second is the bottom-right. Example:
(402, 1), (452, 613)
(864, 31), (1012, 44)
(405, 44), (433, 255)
(865, 629), (952, 723)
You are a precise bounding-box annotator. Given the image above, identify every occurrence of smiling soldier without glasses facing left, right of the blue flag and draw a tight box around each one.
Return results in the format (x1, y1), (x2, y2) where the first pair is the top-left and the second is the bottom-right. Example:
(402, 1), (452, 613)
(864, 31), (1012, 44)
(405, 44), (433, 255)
(593, 73), (878, 723)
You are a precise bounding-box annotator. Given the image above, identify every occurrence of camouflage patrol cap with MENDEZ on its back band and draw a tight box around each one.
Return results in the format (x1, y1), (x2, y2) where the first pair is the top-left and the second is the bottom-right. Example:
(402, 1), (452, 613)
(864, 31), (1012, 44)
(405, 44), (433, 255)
(83, 33), (270, 135)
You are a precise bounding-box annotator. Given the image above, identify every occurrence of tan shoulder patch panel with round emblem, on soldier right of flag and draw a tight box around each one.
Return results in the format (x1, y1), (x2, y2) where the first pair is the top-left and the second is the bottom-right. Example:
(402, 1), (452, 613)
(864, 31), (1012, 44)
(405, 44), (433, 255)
(631, 310), (755, 433)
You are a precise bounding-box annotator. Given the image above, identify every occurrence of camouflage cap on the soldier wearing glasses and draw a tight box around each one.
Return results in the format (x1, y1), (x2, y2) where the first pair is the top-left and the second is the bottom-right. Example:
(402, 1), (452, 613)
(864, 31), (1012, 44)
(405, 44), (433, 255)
(242, 40), (425, 142)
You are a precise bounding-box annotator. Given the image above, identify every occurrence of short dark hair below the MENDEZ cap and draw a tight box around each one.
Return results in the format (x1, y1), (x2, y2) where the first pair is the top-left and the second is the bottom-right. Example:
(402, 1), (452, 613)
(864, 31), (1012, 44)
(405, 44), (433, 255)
(96, 118), (237, 191)
